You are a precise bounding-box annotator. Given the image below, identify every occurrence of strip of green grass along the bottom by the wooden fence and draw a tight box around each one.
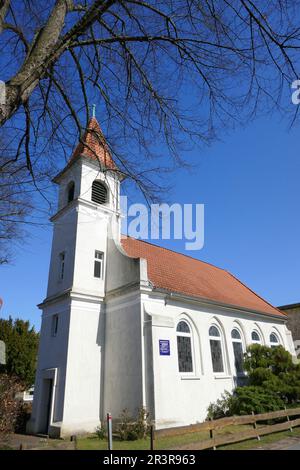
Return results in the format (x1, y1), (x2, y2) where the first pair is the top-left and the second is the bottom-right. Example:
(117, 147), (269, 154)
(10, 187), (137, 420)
(77, 425), (300, 450)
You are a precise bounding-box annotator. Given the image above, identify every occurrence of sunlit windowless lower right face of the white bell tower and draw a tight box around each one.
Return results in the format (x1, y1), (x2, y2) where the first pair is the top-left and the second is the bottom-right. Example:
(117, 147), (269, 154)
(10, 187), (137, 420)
(62, 300), (104, 434)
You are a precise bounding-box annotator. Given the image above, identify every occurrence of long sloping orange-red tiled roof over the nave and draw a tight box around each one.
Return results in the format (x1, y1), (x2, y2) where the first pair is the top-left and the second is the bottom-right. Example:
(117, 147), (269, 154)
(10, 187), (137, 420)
(122, 237), (286, 318)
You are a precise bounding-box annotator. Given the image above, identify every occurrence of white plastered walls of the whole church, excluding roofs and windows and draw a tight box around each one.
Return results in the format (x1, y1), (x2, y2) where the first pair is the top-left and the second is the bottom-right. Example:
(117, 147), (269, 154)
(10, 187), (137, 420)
(28, 146), (294, 436)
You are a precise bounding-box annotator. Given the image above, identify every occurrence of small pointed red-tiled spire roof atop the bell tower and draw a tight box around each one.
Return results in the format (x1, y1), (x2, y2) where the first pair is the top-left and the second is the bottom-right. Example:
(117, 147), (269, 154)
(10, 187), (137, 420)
(69, 117), (117, 170)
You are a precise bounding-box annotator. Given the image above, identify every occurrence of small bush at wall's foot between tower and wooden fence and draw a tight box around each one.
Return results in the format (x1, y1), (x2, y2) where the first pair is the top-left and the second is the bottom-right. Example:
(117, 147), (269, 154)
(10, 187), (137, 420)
(116, 408), (150, 441)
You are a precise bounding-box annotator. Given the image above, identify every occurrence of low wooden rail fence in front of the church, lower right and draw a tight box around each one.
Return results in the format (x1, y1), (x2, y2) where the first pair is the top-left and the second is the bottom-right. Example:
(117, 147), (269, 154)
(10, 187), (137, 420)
(151, 408), (300, 450)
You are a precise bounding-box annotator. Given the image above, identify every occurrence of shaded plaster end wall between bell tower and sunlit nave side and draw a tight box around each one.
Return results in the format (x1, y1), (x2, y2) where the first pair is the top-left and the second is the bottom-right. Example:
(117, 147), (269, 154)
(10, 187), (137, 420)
(103, 293), (143, 419)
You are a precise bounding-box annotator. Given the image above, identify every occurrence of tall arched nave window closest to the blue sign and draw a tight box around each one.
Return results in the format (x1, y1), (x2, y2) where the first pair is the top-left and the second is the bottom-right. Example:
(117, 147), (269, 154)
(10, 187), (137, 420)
(176, 320), (194, 373)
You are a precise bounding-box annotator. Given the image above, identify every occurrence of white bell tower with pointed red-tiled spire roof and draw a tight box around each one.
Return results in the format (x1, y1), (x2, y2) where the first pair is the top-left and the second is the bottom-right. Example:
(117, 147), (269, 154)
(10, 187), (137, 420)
(28, 116), (122, 436)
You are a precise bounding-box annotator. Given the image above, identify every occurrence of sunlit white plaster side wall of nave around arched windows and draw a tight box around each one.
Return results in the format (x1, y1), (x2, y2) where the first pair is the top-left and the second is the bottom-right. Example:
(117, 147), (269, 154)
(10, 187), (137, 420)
(142, 295), (290, 428)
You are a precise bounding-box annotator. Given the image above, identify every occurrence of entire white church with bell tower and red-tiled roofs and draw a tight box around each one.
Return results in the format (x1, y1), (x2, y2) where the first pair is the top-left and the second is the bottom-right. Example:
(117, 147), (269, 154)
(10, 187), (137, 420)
(28, 117), (294, 437)
